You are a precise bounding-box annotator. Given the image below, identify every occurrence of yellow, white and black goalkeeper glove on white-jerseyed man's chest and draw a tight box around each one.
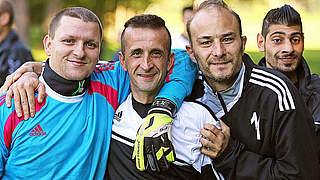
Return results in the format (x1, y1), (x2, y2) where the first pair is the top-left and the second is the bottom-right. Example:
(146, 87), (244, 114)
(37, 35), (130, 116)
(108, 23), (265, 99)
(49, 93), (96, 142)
(132, 99), (175, 172)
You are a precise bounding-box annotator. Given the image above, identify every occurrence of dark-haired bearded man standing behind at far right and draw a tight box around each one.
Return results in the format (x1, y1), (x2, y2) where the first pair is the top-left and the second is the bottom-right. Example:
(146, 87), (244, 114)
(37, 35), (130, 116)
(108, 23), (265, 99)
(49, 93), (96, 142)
(257, 5), (320, 156)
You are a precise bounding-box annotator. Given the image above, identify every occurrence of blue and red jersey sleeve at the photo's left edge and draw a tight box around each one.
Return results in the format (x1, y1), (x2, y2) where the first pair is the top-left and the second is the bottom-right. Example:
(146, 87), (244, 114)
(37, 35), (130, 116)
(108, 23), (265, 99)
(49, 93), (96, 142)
(0, 94), (14, 178)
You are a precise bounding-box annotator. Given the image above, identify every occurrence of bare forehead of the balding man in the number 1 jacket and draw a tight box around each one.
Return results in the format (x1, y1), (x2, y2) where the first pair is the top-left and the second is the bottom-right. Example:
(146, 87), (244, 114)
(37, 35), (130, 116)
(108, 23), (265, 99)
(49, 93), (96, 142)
(190, 7), (240, 39)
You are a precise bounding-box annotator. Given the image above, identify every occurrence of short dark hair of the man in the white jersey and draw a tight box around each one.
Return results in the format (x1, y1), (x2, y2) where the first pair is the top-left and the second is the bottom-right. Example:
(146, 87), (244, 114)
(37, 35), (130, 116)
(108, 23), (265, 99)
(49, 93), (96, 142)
(121, 14), (171, 55)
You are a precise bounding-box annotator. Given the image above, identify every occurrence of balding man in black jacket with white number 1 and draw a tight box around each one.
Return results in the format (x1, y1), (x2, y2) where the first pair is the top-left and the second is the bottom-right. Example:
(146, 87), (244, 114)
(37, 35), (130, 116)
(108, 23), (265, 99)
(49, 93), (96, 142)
(187, 0), (320, 180)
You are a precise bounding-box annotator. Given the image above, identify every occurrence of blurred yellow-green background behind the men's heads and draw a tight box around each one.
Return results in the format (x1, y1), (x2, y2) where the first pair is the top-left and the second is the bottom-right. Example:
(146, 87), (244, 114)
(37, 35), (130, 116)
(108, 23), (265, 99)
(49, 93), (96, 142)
(12, 0), (320, 74)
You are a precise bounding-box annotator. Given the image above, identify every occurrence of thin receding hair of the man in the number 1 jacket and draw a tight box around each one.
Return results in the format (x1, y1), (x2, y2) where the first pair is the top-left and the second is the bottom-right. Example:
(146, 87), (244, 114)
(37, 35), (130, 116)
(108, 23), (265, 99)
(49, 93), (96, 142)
(187, 0), (242, 45)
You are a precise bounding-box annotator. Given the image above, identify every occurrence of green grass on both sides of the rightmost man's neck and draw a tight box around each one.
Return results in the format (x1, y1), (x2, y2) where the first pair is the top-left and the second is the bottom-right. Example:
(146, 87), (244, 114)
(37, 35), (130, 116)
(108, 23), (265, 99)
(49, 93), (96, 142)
(246, 50), (320, 75)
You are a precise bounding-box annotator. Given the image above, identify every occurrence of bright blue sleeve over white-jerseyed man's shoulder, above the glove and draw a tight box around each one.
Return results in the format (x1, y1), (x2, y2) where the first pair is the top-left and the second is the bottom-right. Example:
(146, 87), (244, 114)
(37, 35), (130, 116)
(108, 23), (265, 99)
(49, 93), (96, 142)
(156, 49), (198, 108)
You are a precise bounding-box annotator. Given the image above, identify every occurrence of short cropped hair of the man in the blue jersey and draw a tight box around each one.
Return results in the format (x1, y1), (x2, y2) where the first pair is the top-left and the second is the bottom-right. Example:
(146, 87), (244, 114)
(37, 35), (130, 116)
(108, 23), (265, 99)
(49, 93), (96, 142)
(48, 7), (103, 40)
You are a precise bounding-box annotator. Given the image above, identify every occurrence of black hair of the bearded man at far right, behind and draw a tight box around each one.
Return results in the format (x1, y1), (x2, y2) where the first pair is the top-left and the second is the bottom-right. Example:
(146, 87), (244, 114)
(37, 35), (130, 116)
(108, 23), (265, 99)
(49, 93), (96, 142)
(261, 4), (302, 37)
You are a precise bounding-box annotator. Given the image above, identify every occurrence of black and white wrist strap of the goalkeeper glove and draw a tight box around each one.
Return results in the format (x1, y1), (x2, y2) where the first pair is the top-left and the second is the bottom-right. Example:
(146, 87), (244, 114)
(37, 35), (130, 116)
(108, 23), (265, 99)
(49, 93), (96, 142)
(148, 98), (177, 117)
